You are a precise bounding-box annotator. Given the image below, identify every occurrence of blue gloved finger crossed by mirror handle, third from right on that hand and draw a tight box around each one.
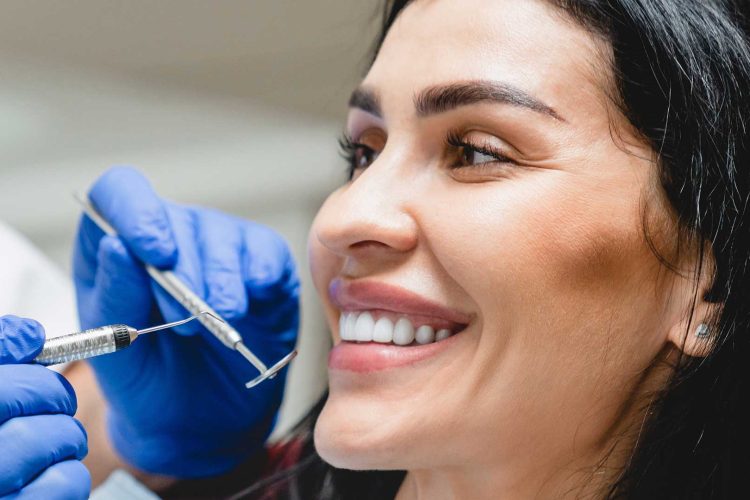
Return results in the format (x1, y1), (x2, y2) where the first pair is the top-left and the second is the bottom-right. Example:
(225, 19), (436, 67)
(153, 206), (206, 335)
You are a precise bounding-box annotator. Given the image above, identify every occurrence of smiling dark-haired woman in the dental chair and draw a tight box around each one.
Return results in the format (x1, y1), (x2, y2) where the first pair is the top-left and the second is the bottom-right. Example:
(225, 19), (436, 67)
(137, 0), (750, 499)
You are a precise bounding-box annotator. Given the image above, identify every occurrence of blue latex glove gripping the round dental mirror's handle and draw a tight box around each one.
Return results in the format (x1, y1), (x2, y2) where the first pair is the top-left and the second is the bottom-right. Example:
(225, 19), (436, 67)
(73, 167), (299, 477)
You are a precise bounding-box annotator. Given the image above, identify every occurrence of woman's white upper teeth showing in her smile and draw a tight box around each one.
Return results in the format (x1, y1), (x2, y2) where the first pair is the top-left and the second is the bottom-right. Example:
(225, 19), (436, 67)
(339, 312), (451, 345)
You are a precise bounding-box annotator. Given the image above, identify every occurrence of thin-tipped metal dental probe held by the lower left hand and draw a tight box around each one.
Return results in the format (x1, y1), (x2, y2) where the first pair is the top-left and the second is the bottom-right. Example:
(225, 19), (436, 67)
(34, 312), (221, 366)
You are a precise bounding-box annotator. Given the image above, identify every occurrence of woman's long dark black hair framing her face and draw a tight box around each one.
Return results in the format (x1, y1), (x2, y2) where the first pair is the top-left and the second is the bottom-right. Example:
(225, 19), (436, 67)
(238, 0), (750, 499)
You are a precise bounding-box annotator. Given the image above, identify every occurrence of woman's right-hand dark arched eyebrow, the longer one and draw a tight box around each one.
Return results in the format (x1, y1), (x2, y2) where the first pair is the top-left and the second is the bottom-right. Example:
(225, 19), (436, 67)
(414, 80), (565, 122)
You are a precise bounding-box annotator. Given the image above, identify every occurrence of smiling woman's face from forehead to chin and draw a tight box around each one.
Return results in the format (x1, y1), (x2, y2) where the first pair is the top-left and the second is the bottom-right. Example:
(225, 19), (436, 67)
(310, 0), (684, 488)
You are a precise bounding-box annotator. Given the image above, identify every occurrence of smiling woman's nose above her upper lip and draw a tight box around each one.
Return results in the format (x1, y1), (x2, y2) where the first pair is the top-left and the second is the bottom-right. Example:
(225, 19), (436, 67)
(316, 156), (418, 256)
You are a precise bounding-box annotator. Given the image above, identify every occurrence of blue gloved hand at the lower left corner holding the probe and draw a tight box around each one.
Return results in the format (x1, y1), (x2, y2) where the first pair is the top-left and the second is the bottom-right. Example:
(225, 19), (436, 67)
(0, 316), (91, 500)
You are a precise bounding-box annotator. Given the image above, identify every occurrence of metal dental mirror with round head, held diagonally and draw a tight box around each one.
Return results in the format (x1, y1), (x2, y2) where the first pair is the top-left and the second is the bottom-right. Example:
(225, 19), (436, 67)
(75, 194), (297, 389)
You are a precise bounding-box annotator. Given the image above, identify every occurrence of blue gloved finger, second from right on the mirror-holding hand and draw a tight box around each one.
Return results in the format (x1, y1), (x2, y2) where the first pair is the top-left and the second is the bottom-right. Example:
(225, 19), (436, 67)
(195, 209), (247, 321)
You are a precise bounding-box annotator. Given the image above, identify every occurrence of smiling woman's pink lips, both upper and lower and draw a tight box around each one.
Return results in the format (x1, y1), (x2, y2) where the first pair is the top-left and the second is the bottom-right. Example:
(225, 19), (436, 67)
(328, 279), (471, 373)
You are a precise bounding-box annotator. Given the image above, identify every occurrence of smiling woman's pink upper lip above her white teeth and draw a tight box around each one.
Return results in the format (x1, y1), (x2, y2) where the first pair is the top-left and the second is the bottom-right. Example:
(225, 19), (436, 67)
(328, 278), (471, 325)
